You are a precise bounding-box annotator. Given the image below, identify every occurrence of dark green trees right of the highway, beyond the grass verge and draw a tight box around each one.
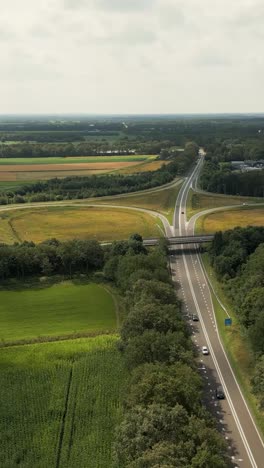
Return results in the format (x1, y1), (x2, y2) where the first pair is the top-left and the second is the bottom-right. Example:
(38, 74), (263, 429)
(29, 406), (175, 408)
(209, 227), (264, 408)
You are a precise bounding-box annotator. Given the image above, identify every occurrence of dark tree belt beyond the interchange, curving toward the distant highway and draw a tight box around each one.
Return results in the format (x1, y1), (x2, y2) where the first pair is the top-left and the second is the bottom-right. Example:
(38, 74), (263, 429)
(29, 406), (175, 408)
(0, 143), (198, 205)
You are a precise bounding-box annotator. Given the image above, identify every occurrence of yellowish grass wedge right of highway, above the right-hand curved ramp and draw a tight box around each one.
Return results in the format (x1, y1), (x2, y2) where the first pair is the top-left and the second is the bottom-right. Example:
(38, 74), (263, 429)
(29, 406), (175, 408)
(187, 189), (264, 219)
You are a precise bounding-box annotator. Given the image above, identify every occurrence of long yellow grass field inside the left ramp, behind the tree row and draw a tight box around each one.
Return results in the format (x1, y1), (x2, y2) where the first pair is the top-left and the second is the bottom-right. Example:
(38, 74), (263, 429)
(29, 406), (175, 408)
(0, 206), (161, 243)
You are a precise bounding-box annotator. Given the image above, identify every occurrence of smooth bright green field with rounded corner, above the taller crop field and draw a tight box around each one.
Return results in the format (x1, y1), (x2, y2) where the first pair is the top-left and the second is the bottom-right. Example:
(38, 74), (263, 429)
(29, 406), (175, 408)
(0, 281), (117, 343)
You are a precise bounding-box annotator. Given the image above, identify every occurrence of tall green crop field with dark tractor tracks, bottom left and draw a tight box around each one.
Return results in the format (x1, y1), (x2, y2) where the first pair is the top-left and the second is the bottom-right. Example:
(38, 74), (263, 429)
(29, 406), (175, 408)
(0, 336), (127, 468)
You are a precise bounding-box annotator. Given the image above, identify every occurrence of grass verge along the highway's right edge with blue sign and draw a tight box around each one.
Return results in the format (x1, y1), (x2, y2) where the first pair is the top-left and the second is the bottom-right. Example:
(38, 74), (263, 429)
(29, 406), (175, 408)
(201, 253), (264, 435)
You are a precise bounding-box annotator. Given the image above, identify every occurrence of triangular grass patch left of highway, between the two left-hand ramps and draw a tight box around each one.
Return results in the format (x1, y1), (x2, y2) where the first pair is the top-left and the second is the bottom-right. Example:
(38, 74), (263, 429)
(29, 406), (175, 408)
(92, 179), (181, 224)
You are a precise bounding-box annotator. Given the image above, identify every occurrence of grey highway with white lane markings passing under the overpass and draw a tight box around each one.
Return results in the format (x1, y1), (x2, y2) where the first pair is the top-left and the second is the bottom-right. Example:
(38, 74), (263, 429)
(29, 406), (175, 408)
(170, 157), (264, 468)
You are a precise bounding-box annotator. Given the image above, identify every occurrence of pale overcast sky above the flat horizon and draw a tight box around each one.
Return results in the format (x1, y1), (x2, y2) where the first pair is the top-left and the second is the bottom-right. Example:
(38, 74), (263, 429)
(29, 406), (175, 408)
(0, 0), (264, 114)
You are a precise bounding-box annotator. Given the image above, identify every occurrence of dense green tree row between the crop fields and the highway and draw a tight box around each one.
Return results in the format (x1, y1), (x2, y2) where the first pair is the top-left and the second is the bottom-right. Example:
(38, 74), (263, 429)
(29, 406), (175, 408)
(103, 235), (230, 468)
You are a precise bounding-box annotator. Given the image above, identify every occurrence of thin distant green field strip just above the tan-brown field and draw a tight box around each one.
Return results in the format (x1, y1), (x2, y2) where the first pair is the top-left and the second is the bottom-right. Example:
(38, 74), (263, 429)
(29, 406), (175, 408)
(0, 154), (156, 166)
